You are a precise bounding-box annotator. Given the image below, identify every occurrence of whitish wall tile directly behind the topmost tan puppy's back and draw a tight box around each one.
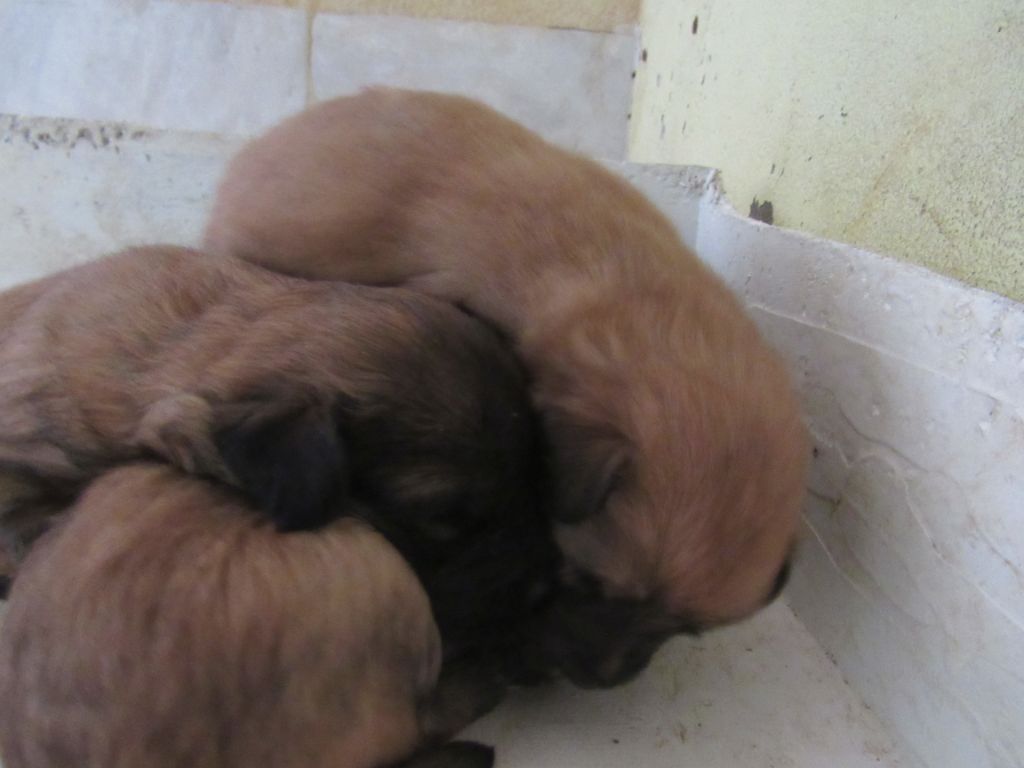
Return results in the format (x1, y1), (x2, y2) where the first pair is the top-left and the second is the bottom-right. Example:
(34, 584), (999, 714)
(312, 14), (636, 158)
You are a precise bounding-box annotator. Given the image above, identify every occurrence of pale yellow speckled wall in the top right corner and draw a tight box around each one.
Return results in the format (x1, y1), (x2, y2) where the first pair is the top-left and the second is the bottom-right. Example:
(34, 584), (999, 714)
(631, 0), (1024, 300)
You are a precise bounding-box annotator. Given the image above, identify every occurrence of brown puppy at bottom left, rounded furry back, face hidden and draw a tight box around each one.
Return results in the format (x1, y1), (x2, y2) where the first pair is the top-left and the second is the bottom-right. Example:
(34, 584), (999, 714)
(0, 464), (493, 768)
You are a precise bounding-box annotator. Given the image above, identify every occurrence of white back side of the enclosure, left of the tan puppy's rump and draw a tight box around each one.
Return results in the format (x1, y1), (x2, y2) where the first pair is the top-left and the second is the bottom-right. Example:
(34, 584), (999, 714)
(0, 116), (232, 289)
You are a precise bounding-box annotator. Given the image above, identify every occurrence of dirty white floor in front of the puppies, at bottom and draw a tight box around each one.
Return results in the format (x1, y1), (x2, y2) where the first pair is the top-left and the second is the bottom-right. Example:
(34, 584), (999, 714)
(466, 603), (908, 768)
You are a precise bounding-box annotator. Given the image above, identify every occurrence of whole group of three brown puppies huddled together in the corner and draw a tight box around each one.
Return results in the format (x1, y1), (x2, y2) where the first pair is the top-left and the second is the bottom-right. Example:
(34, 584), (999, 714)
(0, 89), (809, 768)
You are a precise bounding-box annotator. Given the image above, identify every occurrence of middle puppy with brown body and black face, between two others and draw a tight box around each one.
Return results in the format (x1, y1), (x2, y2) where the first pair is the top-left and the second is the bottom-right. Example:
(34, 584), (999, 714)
(0, 248), (556, 675)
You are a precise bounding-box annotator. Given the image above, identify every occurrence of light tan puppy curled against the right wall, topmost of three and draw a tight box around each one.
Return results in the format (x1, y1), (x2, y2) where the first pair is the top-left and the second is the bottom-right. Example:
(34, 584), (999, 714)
(205, 89), (809, 685)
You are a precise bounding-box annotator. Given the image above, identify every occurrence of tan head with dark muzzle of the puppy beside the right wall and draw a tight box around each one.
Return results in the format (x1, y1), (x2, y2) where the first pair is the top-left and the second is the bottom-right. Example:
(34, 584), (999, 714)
(528, 290), (810, 686)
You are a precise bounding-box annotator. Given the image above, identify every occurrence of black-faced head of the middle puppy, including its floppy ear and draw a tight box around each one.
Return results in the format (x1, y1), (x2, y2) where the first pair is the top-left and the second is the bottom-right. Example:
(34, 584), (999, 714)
(212, 296), (557, 664)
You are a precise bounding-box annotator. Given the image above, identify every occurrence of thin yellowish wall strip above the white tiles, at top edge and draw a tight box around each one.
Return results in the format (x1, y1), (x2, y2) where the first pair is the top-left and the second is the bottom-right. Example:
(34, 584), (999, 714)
(212, 0), (640, 32)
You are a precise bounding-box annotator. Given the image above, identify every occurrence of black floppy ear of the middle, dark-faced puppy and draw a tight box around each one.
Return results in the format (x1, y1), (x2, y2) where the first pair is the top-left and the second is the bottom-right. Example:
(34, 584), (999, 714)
(211, 400), (349, 530)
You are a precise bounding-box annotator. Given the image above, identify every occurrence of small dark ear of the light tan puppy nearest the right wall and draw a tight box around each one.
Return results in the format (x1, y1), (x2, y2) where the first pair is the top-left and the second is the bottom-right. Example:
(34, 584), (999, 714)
(548, 423), (629, 523)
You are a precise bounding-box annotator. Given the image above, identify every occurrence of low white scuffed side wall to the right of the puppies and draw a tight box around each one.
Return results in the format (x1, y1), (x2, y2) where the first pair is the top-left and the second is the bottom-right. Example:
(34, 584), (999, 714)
(628, 168), (1024, 768)
